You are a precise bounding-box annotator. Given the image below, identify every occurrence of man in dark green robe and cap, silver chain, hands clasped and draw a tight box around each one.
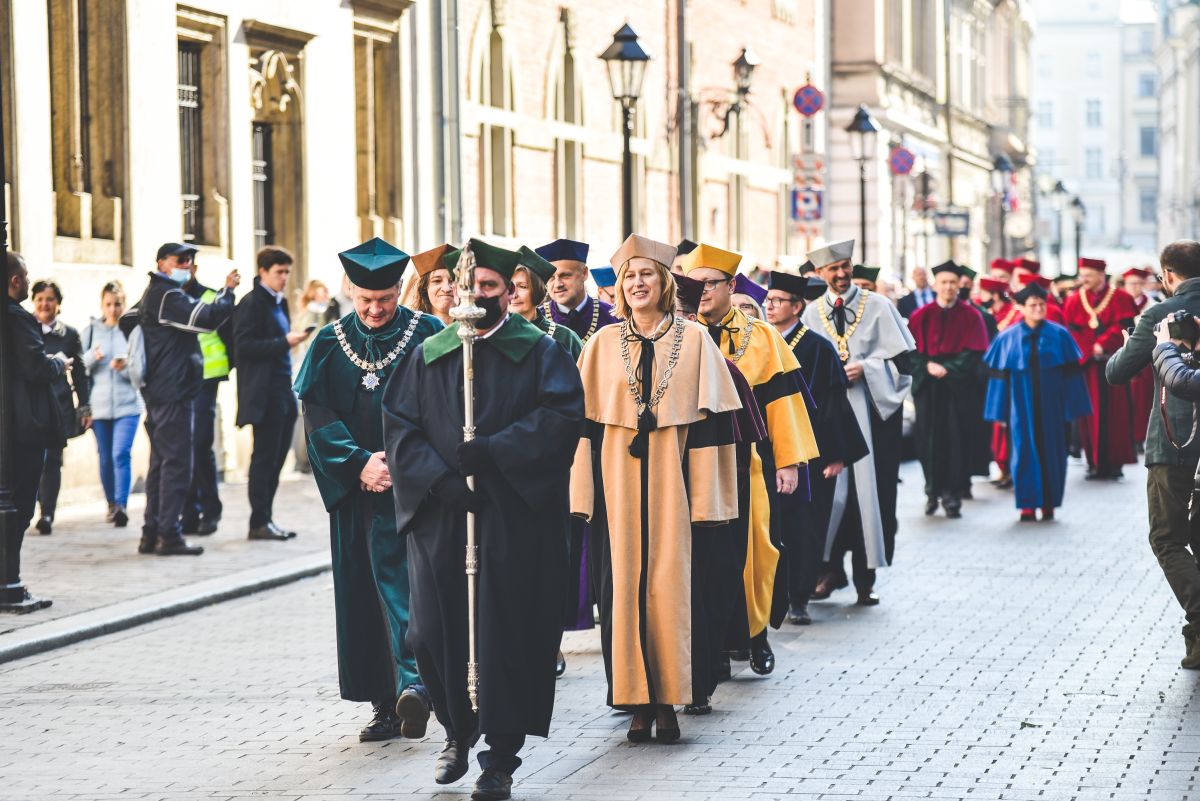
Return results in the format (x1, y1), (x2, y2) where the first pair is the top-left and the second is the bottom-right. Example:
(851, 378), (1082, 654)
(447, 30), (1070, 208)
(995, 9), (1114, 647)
(295, 239), (442, 741)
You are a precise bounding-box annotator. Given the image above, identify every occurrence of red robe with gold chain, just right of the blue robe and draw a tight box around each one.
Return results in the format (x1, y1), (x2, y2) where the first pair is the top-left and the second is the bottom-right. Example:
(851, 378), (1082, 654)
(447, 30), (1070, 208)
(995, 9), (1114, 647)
(1063, 287), (1138, 472)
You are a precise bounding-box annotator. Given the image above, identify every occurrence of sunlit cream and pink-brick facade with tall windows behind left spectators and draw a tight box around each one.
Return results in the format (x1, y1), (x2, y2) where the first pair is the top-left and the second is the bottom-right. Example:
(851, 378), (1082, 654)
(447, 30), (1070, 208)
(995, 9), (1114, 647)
(0, 0), (828, 501)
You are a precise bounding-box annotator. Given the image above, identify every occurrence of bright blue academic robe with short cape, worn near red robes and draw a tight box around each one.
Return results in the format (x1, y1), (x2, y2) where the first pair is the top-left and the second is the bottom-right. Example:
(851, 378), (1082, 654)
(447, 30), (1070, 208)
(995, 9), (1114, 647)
(984, 320), (1092, 510)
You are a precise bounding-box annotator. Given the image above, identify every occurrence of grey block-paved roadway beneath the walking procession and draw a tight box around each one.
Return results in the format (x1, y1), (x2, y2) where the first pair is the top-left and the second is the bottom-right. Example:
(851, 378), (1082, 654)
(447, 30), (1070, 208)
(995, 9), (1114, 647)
(0, 455), (1200, 801)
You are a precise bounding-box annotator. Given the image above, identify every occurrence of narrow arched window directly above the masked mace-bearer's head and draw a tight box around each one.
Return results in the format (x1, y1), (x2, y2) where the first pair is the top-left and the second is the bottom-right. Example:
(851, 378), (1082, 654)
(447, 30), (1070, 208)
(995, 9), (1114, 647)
(478, 17), (516, 236)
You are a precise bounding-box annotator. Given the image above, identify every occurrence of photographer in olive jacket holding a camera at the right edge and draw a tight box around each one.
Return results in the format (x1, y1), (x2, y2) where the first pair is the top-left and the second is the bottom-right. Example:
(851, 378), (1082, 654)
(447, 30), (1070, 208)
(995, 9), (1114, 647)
(1105, 240), (1200, 670)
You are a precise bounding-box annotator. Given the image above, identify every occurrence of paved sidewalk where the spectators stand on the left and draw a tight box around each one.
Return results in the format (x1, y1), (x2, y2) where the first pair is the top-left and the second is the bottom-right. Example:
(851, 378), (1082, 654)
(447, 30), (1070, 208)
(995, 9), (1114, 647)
(0, 472), (329, 652)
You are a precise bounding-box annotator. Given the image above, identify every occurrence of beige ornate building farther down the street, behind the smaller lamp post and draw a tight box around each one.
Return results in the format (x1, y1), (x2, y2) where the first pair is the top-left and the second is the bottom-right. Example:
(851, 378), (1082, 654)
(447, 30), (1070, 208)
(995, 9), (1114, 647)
(829, 0), (1033, 281)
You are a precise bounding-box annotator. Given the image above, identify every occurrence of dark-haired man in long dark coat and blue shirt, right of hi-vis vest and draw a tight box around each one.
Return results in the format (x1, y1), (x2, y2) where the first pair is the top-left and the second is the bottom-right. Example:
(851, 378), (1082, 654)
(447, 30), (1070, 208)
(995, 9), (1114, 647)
(234, 245), (310, 540)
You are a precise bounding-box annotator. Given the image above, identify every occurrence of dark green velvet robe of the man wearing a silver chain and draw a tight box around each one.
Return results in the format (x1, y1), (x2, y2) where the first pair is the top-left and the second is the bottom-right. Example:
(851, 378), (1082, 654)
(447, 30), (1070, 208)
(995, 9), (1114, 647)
(295, 306), (443, 703)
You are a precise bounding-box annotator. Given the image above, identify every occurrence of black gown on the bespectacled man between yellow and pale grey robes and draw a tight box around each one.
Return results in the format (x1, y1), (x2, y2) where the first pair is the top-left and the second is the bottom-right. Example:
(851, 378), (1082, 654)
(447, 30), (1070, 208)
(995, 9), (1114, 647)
(775, 324), (869, 606)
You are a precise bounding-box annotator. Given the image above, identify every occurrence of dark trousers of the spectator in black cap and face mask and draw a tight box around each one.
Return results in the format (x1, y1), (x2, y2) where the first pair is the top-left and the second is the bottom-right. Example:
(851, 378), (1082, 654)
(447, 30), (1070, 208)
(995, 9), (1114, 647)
(142, 401), (194, 542)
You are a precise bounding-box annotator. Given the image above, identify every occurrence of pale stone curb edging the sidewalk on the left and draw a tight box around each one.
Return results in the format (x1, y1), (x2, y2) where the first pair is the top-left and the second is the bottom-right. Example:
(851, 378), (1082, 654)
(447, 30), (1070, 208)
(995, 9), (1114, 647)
(0, 553), (330, 664)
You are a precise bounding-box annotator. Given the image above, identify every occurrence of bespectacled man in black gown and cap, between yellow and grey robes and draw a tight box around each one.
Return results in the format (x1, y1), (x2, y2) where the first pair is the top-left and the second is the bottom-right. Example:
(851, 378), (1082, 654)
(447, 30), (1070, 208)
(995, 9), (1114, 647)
(766, 272), (868, 626)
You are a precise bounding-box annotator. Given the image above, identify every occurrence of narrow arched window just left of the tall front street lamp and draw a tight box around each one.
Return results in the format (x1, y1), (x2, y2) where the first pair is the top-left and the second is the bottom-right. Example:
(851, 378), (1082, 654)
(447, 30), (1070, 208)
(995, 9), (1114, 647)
(553, 8), (583, 239)
